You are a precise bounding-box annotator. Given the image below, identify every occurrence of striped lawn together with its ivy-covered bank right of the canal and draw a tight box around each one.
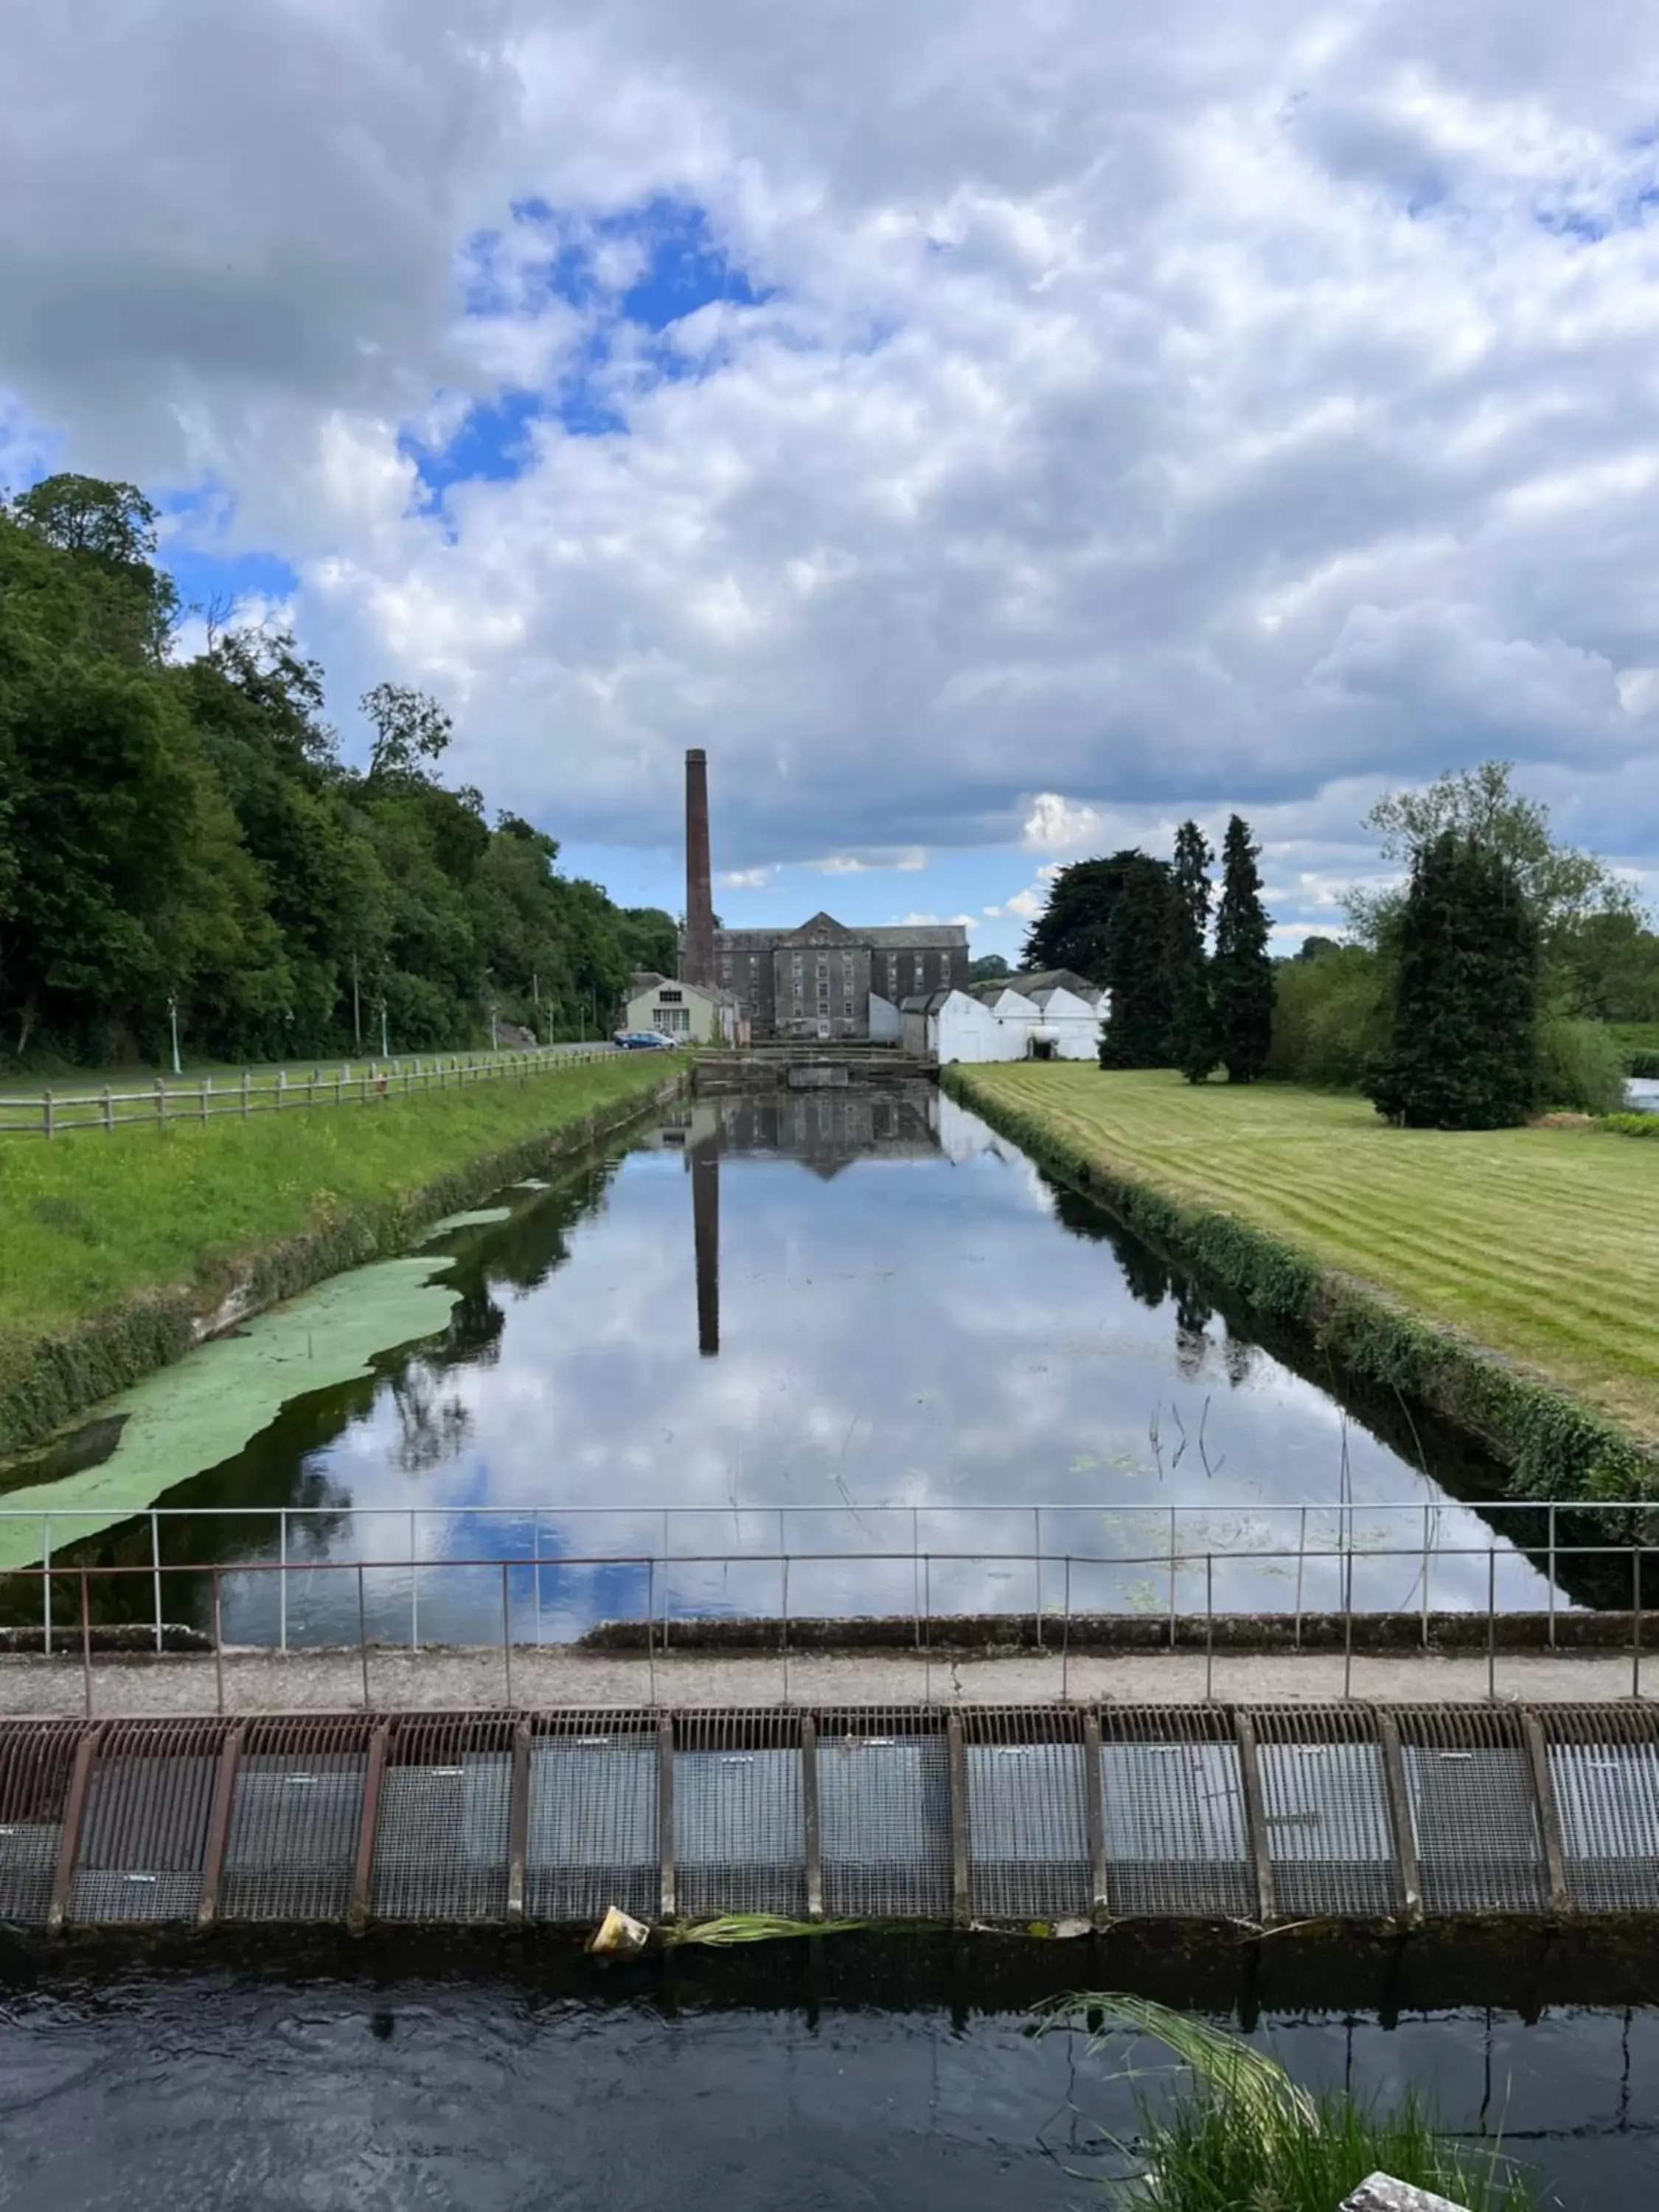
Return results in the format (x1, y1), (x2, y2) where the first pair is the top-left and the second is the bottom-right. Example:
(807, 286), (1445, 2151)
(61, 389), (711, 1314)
(947, 1064), (1659, 1495)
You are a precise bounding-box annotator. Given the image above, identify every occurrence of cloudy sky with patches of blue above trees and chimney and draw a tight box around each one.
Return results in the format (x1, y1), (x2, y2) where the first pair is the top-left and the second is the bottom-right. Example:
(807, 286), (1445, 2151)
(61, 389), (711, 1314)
(0, 0), (1659, 953)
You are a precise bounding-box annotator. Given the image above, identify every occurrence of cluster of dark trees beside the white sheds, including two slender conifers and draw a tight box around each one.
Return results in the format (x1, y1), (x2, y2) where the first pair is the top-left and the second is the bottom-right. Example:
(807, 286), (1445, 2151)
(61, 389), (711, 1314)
(1024, 814), (1274, 1084)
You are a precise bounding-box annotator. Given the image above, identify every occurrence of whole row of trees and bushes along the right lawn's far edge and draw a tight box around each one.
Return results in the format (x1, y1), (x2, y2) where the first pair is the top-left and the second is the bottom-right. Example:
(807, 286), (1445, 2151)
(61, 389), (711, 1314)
(1024, 761), (1659, 1128)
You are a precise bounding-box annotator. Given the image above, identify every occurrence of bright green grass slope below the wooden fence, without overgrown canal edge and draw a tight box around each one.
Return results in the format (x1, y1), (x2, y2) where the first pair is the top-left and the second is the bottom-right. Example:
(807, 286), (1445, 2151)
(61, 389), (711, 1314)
(0, 1053), (679, 1387)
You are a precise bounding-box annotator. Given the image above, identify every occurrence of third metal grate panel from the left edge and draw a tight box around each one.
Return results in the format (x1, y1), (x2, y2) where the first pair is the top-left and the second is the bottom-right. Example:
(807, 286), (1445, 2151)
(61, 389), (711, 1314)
(219, 1719), (369, 1920)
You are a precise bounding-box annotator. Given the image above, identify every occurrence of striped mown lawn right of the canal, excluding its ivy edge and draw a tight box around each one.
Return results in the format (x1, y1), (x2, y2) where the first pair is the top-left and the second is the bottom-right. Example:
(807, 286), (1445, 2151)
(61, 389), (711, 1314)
(960, 1062), (1659, 1440)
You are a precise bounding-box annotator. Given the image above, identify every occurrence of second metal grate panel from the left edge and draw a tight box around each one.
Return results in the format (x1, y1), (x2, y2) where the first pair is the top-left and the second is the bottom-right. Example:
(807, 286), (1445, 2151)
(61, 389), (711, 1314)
(69, 1721), (226, 1922)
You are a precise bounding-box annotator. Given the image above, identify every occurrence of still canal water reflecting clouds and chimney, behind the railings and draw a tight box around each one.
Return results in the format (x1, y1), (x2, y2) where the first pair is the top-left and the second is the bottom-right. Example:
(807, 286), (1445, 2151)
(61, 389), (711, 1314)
(9, 1086), (1575, 1644)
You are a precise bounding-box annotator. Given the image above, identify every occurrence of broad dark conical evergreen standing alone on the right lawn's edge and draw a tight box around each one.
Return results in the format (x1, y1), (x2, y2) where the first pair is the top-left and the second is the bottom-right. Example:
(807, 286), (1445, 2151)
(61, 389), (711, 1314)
(1365, 830), (1540, 1128)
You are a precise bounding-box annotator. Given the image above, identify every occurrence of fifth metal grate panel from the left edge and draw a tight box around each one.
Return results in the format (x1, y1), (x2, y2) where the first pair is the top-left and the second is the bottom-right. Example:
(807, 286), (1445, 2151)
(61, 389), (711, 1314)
(524, 1712), (661, 1922)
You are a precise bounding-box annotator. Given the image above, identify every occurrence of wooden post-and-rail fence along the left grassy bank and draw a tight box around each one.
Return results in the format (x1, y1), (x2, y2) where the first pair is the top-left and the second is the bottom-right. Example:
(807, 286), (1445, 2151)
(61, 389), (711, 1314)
(0, 1044), (617, 1137)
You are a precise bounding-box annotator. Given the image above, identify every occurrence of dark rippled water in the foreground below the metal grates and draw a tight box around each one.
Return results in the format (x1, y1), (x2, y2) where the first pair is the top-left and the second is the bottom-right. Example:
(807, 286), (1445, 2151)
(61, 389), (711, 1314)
(0, 1947), (1659, 2212)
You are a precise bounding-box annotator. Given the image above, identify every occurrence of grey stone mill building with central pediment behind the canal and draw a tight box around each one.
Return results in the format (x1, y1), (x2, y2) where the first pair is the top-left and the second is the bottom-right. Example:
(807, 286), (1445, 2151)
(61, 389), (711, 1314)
(714, 914), (969, 1042)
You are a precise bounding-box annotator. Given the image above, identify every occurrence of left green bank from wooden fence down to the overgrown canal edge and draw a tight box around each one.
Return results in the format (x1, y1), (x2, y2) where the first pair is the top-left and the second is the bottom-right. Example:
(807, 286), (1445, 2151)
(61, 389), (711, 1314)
(0, 1053), (690, 1453)
